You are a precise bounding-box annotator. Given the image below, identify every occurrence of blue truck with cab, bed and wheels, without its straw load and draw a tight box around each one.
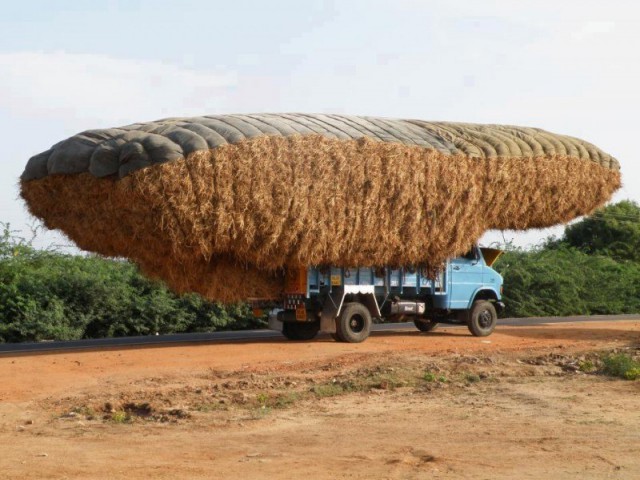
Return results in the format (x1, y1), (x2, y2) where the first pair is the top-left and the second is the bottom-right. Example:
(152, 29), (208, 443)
(269, 246), (504, 343)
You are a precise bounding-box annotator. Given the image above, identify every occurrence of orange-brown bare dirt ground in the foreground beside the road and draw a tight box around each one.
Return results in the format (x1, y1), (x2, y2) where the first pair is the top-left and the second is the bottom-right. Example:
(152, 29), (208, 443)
(0, 321), (640, 479)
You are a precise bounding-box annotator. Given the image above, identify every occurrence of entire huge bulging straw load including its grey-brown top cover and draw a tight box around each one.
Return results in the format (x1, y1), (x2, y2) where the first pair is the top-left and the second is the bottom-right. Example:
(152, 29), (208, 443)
(21, 114), (620, 301)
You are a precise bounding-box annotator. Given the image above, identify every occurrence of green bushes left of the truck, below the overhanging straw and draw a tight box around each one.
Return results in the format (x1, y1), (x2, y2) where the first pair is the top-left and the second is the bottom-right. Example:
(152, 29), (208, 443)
(0, 226), (265, 342)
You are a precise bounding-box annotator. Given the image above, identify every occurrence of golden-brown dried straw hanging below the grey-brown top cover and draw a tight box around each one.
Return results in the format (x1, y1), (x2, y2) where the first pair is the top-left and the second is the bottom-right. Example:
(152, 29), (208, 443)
(22, 135), (620, 302)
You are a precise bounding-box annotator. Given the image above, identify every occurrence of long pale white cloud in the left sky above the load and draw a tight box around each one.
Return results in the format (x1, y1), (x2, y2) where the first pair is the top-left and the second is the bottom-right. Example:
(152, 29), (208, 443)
(0, 52), (236, 127)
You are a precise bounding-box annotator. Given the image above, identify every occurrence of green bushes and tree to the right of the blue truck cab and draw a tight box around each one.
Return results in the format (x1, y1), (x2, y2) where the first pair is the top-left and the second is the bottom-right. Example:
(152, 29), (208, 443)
(495, 201), (640, 317)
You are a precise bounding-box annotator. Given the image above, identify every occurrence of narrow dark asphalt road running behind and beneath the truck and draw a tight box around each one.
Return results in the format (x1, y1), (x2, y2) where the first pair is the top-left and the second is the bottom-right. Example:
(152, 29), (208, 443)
(0, 315), (640, 355)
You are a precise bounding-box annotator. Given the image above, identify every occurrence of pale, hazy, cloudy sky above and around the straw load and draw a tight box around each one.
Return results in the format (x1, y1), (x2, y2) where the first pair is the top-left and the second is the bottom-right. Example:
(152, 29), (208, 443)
(0, 0), (640, 251)
